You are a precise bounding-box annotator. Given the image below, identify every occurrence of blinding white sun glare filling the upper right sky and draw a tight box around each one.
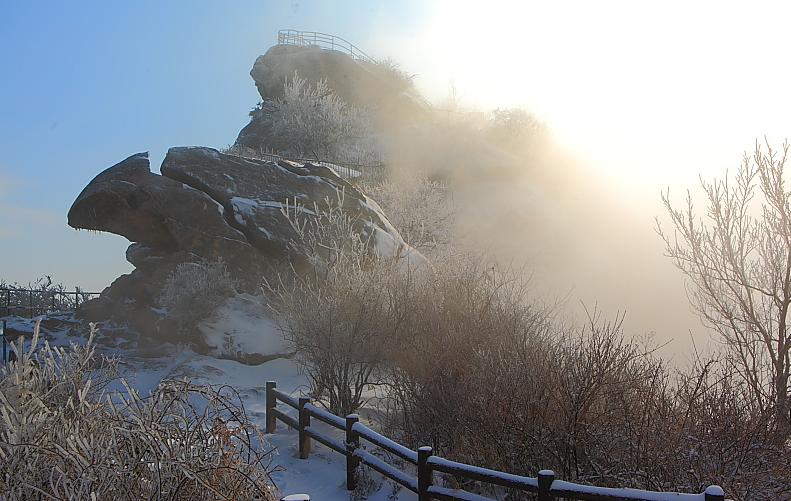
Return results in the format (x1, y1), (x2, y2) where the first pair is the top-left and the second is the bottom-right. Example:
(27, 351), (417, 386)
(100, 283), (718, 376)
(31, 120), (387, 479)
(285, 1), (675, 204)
(397, 1), (791, 196)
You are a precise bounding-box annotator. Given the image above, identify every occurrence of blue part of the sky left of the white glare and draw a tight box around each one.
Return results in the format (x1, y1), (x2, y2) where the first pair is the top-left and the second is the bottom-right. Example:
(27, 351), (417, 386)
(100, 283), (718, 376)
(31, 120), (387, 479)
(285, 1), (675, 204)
(0, 0), (418, 289)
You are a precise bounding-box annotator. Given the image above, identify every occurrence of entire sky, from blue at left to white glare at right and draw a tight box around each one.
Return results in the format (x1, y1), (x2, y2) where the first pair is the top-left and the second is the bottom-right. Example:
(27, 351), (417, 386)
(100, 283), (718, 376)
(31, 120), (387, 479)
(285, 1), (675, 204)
(0, 0), (791, 350)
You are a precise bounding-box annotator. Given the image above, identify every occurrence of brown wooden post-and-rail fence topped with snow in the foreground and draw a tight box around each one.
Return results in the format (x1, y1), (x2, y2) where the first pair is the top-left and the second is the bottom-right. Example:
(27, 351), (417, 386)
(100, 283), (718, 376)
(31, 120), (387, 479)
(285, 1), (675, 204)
(266, 381), (725, 501)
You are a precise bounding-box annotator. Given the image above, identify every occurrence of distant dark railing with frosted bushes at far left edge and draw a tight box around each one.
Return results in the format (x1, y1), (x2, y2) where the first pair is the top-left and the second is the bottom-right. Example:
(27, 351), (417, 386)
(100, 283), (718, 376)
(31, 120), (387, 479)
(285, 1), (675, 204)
(0, 287), (99, 318)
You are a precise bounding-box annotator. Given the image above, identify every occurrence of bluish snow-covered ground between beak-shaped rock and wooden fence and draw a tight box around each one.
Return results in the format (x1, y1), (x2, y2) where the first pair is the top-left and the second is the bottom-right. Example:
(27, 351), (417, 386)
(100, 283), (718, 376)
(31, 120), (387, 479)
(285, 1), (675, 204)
(1, 308), (408, 501)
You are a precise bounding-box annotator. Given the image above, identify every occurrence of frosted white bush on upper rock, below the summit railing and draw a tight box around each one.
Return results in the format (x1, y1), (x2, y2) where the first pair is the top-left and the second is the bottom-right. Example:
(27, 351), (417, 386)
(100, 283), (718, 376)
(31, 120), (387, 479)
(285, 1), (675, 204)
(252, 73), (380, 164)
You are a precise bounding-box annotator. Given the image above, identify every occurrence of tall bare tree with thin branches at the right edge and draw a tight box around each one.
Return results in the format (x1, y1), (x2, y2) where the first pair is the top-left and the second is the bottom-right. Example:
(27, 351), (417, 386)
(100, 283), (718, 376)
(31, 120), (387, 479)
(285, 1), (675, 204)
(657, 143), (791, 437)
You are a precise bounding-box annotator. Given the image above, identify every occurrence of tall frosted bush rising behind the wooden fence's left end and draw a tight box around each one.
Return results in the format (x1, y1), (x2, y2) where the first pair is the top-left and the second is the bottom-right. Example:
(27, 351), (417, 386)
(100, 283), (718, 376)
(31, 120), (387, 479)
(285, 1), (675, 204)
(265, 194), (397, 415)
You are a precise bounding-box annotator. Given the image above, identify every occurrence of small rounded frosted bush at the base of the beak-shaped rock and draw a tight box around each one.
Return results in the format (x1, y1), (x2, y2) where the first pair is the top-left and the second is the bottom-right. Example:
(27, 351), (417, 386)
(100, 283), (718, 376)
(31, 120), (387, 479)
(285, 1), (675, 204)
(159, 261), (237, 330)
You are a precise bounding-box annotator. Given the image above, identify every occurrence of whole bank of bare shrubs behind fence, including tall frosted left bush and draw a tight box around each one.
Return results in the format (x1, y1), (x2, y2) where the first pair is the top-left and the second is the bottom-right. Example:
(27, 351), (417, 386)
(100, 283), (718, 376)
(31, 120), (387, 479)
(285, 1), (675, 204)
(273, 192), (791, 499)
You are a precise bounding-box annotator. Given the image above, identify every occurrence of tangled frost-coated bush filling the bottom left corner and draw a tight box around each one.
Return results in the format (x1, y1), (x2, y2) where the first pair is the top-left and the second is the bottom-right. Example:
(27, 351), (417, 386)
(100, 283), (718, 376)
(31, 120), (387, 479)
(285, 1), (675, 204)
(0, 322), (277, 500)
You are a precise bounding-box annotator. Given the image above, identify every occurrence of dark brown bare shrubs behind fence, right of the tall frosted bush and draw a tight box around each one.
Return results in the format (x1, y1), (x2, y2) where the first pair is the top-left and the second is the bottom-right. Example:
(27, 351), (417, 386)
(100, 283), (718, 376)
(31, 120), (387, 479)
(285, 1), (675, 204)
(386, 290), (791, 499)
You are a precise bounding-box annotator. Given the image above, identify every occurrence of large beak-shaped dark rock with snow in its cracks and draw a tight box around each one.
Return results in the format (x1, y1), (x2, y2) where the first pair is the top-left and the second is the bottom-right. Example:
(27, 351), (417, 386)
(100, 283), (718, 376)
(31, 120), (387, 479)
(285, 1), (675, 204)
(68, 147), (423, 337)
